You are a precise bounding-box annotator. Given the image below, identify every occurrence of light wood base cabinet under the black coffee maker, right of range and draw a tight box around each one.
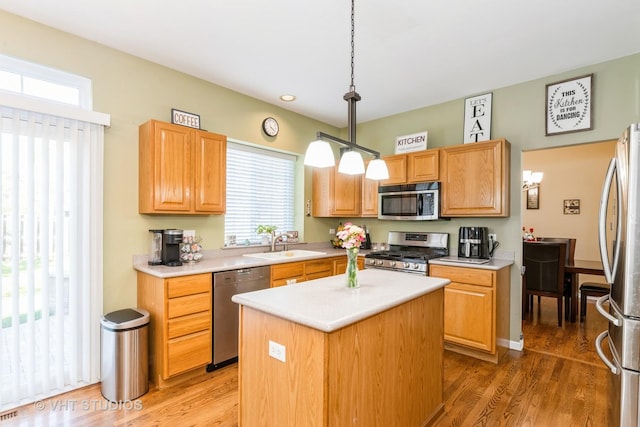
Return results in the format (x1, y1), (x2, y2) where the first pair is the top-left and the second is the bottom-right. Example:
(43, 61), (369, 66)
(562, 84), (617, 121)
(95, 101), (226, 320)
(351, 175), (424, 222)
(429, 264), (510, 363)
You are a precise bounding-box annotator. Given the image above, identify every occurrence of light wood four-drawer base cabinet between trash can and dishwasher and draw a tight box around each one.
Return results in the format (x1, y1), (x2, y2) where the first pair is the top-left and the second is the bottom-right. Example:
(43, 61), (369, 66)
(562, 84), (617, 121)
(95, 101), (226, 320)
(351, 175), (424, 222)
(138, 272), (212, 388)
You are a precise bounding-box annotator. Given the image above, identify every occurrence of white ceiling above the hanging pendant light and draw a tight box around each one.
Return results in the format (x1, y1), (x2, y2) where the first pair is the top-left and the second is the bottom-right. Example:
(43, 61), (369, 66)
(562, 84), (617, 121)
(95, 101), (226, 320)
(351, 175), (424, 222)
(0, 0), (640, 127)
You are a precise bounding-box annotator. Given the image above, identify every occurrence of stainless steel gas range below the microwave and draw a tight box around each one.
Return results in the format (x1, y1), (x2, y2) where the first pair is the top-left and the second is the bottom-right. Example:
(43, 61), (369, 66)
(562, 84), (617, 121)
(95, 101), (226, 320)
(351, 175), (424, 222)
(364, 231), (449, 274)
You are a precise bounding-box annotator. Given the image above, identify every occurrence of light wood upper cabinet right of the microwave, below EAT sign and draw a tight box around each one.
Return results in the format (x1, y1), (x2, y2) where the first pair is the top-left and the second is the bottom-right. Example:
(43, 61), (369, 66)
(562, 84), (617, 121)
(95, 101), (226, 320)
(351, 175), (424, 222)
(440, 139), (511, 217)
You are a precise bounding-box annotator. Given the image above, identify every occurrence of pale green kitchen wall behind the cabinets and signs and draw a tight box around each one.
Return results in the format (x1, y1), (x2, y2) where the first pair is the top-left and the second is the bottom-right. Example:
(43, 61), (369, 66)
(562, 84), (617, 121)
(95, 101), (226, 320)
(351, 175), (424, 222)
(0, 11), (640, 341)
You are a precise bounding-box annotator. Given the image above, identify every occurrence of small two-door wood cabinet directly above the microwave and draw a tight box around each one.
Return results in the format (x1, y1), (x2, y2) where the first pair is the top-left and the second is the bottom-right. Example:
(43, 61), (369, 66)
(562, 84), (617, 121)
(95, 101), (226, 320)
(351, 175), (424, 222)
(380, 148), (440, 185)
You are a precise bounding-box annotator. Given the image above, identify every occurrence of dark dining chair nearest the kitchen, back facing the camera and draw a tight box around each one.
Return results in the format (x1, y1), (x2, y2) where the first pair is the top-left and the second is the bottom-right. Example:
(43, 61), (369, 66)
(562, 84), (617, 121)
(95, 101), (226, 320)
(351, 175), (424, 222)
(522, 241), (571, 326)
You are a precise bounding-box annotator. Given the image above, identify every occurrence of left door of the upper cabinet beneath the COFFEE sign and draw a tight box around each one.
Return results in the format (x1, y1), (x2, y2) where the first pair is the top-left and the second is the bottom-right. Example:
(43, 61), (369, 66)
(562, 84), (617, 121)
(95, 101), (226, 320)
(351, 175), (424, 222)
(140, 120), (193, 213)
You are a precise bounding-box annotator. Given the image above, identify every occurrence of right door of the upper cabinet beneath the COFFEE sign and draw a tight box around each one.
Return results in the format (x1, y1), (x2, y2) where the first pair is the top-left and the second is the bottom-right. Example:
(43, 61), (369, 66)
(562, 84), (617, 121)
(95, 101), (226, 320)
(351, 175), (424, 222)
(193, 131), (227, 214)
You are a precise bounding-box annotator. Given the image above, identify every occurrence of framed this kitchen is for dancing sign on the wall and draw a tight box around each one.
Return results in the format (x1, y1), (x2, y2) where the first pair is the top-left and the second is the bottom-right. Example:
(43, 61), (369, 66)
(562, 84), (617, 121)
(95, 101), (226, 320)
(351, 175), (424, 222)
(544, 74), (593, 136)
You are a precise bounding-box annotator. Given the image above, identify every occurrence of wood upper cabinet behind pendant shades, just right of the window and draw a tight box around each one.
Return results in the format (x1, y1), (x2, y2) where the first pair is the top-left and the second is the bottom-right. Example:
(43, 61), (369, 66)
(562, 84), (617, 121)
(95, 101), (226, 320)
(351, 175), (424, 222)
(312, 167), (362, 217)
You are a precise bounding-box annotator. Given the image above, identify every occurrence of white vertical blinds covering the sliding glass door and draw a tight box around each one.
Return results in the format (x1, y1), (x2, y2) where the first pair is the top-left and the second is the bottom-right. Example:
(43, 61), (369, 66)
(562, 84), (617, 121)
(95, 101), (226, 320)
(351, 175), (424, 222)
(0, 107), (104, 410)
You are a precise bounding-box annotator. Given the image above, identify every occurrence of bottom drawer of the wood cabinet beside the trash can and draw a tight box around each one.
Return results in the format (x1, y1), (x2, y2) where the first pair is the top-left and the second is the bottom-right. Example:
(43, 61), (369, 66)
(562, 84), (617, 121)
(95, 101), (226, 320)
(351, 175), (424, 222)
(164, 331), (211, 378)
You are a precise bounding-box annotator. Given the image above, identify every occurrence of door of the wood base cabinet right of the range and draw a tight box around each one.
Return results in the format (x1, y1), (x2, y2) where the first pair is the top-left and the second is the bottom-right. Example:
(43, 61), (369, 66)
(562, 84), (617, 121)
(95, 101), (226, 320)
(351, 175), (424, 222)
(444, 282), (495, 354)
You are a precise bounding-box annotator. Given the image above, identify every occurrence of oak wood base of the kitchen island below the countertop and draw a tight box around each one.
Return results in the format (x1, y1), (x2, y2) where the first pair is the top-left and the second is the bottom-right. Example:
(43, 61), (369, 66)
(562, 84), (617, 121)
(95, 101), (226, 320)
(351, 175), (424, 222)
(238, 288), (444, 427)
